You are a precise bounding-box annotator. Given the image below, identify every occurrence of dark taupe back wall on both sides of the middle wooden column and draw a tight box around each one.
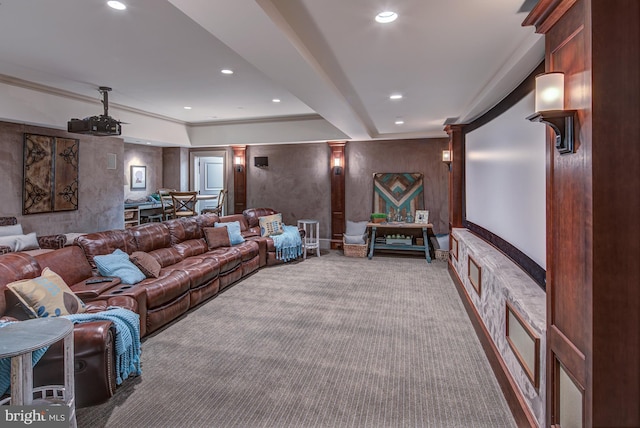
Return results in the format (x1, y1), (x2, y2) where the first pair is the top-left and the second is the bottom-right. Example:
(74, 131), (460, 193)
(247, 138), (449, 239)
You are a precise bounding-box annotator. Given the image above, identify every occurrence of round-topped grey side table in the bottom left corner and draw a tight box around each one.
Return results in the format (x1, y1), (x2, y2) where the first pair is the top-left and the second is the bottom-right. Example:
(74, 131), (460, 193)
(0, 318), (76, 427)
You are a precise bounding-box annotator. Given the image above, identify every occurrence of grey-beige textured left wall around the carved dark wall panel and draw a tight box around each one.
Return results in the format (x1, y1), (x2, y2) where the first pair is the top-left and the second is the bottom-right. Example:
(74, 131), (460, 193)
(0, 122), (124, 235)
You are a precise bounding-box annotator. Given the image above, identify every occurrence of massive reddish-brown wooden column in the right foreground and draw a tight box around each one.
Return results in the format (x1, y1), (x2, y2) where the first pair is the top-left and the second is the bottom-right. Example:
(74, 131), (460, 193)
(524, 0), (640, 427)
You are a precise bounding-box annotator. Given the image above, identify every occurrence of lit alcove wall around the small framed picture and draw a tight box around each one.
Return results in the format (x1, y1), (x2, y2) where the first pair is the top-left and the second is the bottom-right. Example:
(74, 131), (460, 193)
(124, 143), (163, 201)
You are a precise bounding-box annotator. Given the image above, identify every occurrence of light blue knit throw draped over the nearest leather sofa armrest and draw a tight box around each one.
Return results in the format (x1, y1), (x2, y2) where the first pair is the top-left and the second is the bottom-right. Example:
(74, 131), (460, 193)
(64, 307), (142, 385)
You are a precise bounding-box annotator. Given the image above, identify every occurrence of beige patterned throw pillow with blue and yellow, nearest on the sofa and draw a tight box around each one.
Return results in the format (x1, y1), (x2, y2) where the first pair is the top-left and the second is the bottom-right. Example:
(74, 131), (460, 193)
(7, 268), (85, 318)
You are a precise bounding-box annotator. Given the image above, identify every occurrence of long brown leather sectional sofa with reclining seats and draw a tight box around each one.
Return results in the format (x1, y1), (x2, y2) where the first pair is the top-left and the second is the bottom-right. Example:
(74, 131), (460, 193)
(0, 208), (300, 407)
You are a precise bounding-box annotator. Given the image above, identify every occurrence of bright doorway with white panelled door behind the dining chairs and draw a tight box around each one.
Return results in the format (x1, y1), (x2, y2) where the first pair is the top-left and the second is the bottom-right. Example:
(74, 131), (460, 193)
(191, 151), (226, 215)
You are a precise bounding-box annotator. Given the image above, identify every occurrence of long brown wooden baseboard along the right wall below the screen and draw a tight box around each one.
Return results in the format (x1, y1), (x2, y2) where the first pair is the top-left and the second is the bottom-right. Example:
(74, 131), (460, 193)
(449, 260), (538, 428)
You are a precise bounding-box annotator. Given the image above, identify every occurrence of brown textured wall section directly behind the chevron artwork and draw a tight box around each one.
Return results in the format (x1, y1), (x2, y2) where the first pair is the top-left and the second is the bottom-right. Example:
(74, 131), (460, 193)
(345, 138), (449, 233)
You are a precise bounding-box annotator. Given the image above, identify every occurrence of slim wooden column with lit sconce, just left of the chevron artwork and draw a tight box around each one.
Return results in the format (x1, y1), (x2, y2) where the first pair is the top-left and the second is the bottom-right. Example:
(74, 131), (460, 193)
(328, 141), (347, 249)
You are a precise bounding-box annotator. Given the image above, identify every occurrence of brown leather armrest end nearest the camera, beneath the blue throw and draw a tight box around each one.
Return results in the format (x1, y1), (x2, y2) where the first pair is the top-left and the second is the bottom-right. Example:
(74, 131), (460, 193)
(33, 321), (116, 407)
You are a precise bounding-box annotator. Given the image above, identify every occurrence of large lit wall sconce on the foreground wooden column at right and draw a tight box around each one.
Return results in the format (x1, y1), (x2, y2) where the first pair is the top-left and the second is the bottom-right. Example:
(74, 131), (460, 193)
(527, 72), (576, 154)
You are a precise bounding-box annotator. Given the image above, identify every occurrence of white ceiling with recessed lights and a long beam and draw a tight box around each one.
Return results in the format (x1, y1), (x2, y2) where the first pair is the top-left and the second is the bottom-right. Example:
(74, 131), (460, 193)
(0, 0), (544, 143)
